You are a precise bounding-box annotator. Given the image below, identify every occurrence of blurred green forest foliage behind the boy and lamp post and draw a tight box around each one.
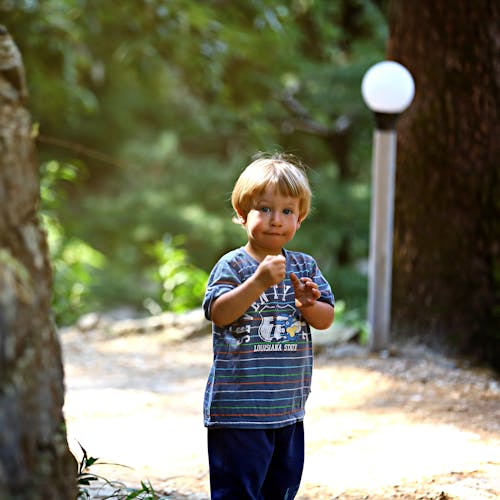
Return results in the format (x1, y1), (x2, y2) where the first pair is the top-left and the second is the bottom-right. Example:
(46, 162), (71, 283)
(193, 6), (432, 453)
(0, 0), (387, 328)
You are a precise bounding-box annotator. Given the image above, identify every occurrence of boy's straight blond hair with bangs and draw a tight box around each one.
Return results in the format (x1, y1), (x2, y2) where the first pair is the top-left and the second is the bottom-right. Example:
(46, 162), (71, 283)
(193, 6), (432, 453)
(231, 154), (312, 223)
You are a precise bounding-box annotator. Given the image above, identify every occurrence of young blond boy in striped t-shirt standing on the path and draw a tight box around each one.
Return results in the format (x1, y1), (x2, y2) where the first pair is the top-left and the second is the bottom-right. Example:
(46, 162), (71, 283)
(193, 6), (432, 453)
(203, 155), (334, 500)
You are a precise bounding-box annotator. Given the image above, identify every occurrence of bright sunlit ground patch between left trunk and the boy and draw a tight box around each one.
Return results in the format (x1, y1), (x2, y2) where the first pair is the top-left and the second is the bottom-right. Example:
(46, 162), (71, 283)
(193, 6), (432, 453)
(65, 389), (206, 481)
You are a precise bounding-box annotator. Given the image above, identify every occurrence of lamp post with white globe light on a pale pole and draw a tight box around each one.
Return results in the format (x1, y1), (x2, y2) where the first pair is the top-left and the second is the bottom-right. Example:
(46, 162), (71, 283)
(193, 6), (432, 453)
(361, 61), (415, 351)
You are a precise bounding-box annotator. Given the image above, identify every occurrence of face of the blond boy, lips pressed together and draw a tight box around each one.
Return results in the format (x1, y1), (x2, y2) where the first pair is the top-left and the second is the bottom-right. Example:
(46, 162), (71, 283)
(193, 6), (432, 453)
(239, 187), (301, 259)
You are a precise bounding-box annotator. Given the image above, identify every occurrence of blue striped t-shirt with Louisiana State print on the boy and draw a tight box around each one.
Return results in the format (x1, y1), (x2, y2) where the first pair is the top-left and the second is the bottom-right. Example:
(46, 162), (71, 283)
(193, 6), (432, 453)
(203, 247), (334, 429)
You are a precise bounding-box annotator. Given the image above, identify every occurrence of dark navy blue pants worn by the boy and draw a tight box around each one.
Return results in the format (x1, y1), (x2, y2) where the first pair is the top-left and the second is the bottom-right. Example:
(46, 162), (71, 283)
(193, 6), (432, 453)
(208, 422), (304, 500)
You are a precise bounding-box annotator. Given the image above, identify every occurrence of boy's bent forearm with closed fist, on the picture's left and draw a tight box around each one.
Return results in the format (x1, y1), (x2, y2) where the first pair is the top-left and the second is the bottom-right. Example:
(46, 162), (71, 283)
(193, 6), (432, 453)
(210, 255), (286, 326)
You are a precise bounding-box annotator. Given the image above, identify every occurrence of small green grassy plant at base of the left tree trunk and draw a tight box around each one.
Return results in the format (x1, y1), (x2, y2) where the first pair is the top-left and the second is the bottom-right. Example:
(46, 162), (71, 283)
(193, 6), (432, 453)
(77, 443), (167, 500)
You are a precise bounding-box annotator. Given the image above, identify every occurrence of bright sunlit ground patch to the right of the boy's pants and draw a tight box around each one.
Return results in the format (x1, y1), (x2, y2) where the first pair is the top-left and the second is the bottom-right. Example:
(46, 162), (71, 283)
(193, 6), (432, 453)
(304, 418), (500, 491)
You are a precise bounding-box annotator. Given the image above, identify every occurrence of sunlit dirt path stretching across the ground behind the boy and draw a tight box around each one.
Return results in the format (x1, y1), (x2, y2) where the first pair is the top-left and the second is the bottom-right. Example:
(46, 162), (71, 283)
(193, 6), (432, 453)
(62, 331), (500, 500)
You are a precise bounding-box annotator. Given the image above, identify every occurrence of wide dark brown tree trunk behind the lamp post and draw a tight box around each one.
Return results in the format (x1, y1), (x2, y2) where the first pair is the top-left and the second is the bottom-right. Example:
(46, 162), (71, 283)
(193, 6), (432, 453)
(388, 0), (500, 363)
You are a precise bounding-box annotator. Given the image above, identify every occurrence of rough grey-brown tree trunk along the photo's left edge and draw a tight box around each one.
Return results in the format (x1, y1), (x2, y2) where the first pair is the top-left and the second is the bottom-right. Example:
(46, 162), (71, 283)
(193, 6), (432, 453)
(0, 26), (76, 500)
